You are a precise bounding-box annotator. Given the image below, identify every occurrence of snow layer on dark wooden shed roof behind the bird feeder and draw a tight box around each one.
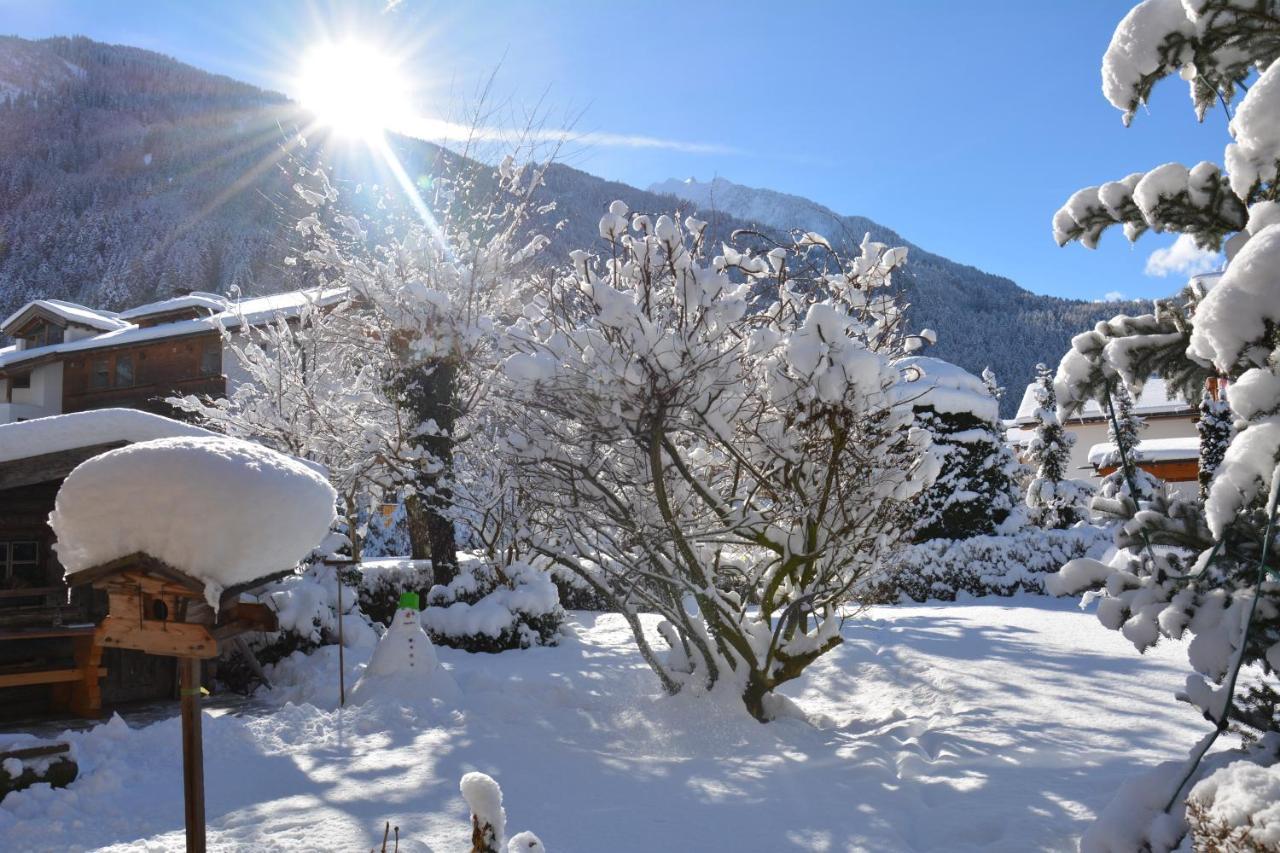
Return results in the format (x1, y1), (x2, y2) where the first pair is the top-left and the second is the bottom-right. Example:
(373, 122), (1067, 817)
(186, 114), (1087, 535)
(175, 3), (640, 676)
(0, 409), (214, 462)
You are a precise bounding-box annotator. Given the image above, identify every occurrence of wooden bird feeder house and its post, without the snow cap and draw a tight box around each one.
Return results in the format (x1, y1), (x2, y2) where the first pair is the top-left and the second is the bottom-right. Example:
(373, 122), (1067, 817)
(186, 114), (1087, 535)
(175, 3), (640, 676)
(72, 553), (279, 853)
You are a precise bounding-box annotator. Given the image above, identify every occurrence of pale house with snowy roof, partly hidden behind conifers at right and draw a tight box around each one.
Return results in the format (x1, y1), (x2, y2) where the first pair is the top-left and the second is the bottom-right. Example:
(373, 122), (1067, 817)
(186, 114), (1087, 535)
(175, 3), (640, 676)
(1005, 377), (1199, 491)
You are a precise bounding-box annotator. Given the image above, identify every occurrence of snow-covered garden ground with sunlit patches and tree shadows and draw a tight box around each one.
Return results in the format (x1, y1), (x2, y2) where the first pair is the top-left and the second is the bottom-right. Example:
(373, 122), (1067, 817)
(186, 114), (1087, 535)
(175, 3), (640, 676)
(0, 597), (1206, 853)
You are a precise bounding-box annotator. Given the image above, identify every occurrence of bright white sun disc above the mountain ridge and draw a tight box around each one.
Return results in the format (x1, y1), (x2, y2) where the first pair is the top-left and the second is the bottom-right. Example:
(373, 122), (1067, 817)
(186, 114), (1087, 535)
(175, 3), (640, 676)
(298, 41), (410, 138)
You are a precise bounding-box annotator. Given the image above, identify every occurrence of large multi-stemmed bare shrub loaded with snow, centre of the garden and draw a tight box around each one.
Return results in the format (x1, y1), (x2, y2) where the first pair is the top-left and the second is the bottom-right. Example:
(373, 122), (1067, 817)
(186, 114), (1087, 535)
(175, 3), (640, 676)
(500, 201), (937, 720)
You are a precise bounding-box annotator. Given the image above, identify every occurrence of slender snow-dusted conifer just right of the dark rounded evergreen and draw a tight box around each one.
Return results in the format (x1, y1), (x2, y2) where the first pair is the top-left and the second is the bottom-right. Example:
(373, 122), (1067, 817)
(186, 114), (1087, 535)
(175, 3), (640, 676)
(1027, 364), (1088, 530)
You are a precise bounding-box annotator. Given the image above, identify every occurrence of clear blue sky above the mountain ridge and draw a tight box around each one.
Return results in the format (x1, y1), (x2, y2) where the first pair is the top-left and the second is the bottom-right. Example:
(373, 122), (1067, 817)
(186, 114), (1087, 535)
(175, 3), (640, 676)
(0, 0), (1228, 300)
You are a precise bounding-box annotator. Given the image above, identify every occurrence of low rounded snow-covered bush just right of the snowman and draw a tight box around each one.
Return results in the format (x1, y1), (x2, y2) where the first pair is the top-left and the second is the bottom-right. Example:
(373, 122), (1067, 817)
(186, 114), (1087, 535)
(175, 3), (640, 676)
(422, 557), (564, 652)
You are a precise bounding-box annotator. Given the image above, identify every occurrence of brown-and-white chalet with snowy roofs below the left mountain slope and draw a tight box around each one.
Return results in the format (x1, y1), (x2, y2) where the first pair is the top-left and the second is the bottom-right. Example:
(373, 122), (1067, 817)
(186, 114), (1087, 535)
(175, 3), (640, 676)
(0, 289), (344, 424)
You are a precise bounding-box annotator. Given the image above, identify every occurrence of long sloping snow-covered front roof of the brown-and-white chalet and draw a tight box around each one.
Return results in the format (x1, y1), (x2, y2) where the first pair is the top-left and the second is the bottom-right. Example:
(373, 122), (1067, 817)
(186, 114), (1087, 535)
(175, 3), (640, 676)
(0, 287), (347, 368)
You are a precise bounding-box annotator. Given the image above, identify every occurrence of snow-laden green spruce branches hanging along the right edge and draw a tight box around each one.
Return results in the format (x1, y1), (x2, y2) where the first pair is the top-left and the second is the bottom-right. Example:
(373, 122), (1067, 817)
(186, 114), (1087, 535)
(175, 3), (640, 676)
(1053, 0), (1280, 849)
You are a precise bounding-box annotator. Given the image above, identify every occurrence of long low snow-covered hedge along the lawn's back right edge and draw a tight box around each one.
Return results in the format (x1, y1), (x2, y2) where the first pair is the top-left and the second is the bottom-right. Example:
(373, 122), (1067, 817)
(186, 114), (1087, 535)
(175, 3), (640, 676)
(878, 524), (1112, 601)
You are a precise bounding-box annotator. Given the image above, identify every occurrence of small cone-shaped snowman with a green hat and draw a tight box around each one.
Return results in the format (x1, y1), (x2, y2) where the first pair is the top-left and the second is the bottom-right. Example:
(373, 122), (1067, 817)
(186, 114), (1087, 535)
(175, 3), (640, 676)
(351, 593), (458, 703)
